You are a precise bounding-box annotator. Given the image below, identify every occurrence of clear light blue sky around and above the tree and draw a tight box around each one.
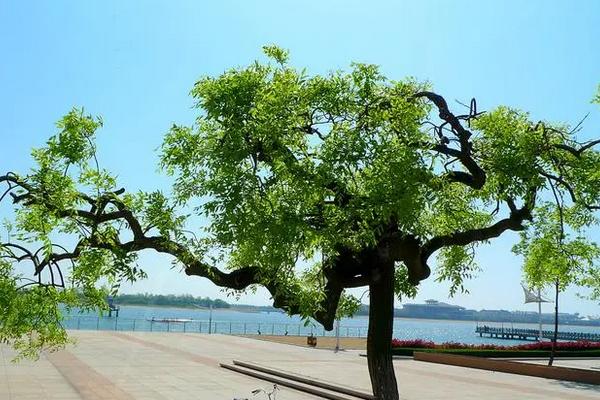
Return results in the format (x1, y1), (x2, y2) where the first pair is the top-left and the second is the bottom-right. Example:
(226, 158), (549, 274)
(0, 0), (600, 315)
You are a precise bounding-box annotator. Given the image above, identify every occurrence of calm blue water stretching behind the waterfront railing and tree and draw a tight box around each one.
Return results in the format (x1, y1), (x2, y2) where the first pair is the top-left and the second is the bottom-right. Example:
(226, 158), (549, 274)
(65, 306), (600, 345)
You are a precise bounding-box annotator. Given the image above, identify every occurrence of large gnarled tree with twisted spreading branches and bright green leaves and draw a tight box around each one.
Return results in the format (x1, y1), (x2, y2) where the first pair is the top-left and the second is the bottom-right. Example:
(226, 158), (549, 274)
(0, 47), (600, 399)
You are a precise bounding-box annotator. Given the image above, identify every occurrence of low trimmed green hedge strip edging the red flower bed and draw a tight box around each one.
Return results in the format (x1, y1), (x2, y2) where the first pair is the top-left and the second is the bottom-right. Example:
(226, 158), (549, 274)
(392, 347), (600, 358)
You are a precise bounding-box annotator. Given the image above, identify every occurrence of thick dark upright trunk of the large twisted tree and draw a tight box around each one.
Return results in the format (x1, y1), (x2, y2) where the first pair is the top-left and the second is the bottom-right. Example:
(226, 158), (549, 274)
(367, 262), (399, 400)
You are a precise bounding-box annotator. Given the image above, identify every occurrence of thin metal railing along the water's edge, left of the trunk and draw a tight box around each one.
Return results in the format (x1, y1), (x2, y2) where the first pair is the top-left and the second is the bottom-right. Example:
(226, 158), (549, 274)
(63, 316), (368, 337)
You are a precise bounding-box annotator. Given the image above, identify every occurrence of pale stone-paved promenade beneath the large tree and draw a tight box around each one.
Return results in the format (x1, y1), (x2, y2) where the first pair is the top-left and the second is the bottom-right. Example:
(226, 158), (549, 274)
(0, 331), (600, 400)
